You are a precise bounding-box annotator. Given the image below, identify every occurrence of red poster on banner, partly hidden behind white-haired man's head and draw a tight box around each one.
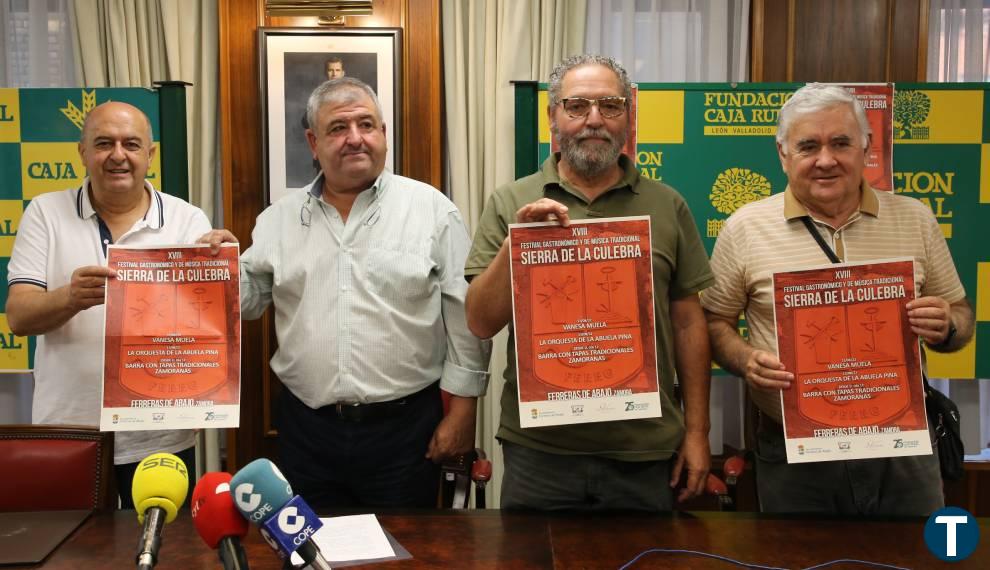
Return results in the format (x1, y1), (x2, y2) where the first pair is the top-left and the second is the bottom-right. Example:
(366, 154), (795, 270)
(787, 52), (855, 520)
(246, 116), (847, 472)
(845, 83), (894, 192)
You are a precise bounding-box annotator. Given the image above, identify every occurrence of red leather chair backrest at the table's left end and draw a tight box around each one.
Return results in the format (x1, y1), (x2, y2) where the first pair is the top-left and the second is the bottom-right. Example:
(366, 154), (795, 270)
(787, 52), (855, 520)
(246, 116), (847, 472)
(0, 425), (117, 512)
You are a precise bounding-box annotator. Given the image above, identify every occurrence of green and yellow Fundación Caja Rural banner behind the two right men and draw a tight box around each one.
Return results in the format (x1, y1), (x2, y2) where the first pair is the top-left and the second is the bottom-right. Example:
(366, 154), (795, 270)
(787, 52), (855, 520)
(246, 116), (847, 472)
(515, 83), (990, 378)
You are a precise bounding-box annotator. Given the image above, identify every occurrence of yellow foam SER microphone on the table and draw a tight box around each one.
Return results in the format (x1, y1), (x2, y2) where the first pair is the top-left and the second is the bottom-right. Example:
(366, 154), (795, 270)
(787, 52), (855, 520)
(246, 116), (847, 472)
(131, 453), (189, 570)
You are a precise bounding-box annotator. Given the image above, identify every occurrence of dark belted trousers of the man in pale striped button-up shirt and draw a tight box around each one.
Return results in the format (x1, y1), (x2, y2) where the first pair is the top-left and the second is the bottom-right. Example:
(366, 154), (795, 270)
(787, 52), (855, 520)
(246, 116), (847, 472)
(277, 383), (443, 508)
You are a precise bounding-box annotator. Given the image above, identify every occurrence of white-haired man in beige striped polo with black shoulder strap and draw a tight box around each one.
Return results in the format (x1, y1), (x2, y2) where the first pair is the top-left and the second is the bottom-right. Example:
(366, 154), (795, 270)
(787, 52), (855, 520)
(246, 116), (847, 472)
(702, 83), (973, 516)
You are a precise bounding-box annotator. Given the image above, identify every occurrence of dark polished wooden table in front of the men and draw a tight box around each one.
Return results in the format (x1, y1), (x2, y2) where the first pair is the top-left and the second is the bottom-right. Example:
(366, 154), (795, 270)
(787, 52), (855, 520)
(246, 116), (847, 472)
(25, 510), (990, 570)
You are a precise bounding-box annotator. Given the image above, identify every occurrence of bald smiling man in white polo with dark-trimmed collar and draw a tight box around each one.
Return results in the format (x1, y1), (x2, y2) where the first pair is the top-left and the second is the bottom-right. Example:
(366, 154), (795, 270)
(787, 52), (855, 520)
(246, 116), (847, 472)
(7, 102), (210, 508)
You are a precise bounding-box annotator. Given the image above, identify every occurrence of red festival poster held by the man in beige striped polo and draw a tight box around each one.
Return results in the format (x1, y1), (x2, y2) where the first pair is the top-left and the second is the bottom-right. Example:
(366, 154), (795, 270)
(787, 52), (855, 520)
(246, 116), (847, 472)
(773, 259), (932, 463)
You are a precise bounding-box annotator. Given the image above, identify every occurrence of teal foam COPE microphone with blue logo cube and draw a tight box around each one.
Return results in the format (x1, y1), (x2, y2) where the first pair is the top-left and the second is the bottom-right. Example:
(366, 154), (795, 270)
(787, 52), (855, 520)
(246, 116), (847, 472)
(230, 459), (330, 570)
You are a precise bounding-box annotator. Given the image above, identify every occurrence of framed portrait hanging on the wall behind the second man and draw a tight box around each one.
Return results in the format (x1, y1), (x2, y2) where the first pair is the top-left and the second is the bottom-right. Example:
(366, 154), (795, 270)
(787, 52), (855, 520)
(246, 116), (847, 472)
(258, 28), (402, 204)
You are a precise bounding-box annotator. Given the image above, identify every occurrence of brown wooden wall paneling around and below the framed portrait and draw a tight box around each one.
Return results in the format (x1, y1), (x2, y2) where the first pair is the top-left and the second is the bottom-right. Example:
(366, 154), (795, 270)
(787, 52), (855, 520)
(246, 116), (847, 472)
(225, 0), (443, 471)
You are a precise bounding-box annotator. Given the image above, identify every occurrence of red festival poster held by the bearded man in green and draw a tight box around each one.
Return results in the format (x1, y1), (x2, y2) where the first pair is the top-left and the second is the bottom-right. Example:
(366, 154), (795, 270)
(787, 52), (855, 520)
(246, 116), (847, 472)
(509, 216), (661, 428)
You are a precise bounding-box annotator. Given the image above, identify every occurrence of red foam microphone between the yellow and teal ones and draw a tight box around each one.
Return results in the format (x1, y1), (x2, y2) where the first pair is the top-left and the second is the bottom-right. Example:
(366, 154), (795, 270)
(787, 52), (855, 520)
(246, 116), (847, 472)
(191, 472), (248, 570)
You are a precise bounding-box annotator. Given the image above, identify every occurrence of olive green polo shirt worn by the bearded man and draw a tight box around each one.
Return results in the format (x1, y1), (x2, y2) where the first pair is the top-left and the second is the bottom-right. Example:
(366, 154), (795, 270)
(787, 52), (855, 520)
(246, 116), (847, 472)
(464, 155), (714, 461)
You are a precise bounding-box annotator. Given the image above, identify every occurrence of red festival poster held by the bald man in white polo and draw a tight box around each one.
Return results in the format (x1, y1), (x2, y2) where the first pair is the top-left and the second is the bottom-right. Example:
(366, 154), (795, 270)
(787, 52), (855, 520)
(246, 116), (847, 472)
(100, 244), (241, 431)
